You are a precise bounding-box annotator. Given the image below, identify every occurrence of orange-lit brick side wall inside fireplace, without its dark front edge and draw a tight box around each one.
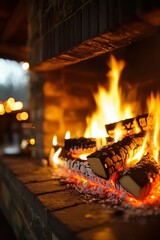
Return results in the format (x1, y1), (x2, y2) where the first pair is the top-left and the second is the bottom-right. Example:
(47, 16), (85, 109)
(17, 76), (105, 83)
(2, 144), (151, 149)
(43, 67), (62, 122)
(43, 69), (98, 156)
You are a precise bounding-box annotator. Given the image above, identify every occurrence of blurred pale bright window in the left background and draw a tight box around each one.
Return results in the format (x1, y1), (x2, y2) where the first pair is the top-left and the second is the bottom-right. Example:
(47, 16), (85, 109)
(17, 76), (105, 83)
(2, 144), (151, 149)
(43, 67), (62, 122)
(0, 58), (29, 108)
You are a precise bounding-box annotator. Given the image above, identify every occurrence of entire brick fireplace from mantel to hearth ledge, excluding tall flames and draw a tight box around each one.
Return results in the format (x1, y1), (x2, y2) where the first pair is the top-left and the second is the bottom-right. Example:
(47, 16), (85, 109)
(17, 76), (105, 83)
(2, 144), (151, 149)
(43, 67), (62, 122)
(0, 0), (160, 239)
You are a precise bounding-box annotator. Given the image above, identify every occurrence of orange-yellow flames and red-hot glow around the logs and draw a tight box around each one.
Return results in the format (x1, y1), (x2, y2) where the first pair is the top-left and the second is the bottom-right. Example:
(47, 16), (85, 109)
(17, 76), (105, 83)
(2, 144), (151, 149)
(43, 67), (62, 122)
(53, 56), (160, 207)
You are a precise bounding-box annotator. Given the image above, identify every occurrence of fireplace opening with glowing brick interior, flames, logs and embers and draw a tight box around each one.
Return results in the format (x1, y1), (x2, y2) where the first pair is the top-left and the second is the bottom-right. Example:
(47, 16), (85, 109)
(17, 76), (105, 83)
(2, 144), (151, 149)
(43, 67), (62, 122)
(28, 30), (160, 214)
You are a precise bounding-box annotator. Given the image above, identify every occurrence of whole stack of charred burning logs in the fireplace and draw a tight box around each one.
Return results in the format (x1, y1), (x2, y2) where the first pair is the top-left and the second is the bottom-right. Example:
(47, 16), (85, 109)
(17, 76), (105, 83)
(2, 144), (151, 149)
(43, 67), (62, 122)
(52, 114), (159, 200)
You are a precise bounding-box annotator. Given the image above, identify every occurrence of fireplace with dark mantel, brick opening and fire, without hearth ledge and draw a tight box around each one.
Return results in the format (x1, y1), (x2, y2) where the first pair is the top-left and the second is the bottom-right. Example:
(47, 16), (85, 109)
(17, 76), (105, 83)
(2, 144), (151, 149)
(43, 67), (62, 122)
(24, 1), (160, 224)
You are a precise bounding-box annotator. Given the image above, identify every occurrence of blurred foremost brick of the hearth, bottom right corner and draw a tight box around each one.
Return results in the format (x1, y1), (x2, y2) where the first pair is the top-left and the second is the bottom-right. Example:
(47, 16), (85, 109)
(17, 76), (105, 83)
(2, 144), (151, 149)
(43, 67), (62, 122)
(78, 217), (160, 240)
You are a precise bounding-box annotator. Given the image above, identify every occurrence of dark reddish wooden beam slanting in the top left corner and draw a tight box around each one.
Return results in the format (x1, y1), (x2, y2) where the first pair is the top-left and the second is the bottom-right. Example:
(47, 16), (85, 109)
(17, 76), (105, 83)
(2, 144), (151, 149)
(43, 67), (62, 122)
(2, 0), (26, 42)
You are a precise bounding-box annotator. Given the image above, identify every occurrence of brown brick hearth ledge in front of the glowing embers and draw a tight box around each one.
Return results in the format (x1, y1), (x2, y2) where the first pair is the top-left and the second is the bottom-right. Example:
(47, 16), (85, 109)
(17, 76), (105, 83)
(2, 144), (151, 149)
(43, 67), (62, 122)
(0, 157), (160, 240)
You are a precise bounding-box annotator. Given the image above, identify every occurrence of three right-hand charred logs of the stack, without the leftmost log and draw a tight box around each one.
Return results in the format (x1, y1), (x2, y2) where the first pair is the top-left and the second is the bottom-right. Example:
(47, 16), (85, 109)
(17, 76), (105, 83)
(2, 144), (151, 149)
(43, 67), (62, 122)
(87, 114), (159, 200)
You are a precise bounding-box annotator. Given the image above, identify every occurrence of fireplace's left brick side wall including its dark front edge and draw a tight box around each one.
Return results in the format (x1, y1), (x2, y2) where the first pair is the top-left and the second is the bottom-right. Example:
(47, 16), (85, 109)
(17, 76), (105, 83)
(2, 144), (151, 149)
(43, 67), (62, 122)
(30, 69), (99, 158)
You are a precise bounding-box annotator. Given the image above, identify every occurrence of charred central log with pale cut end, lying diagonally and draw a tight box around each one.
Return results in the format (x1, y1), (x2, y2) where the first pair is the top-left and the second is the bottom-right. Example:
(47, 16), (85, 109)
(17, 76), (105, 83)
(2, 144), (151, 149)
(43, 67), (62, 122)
(87, 133), (144, 179)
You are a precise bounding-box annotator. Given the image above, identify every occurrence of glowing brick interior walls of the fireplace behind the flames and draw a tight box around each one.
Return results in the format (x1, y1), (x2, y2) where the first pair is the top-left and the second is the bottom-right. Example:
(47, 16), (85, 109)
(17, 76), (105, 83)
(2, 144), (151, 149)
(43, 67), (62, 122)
(37, 30), (160, 155)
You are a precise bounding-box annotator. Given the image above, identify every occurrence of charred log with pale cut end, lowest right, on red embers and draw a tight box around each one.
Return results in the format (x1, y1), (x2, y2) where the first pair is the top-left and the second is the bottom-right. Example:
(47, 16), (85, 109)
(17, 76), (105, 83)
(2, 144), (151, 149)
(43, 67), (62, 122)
(118, 155), (159, 200)
